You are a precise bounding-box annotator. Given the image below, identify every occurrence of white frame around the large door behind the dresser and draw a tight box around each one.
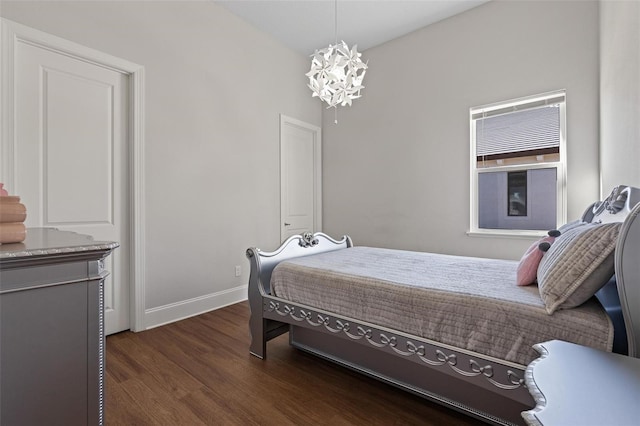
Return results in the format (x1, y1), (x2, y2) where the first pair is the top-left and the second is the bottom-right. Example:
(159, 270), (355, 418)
(0, 18), (146, 331)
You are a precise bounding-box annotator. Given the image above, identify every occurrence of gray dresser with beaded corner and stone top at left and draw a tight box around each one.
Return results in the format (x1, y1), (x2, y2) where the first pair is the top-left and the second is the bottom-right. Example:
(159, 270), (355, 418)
(0, 228), (118, 426)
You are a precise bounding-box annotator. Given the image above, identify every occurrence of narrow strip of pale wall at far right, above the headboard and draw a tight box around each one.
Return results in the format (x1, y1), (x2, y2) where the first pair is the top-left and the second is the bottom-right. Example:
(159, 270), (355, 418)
(600, 1), (640, 195)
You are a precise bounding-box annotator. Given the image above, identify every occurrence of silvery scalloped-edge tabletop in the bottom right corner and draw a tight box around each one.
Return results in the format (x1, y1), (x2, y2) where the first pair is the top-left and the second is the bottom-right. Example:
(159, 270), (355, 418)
(522, 340), (640, 426)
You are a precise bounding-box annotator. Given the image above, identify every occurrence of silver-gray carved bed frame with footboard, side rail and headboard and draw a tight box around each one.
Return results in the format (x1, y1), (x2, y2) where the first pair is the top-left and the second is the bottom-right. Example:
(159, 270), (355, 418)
(247, 187), (640, 425)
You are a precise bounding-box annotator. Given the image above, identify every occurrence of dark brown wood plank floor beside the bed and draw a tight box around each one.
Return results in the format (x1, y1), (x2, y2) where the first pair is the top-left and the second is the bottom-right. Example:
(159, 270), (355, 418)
(106, 303), (478, 426)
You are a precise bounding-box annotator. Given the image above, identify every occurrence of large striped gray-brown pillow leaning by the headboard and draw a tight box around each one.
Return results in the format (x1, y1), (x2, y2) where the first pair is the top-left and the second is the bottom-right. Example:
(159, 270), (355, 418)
(538, 223), (621, 314)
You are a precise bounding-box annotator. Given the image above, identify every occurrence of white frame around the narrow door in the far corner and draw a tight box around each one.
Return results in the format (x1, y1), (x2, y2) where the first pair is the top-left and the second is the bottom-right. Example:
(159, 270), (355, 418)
(280, 114), (322, 239)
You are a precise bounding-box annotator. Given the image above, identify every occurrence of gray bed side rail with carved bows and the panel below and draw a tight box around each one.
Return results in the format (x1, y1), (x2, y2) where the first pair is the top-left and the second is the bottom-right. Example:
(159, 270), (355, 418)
(264, 296), (534, 425)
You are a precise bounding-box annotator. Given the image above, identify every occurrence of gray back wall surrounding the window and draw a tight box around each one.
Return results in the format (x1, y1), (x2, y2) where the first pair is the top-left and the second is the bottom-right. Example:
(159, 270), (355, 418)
(323, 1), (599, 259)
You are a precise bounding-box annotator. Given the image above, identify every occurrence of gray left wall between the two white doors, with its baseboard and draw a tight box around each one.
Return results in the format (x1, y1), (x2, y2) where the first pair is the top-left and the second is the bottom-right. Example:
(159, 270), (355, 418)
(0, 1), (322, 325)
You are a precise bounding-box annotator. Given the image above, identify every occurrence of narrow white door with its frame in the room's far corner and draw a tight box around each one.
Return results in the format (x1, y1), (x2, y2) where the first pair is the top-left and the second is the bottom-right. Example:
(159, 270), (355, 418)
(280, 116), (322, 241)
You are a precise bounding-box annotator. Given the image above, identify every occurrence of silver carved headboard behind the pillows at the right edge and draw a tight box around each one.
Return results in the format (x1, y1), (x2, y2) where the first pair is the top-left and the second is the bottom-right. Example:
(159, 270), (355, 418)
(582, 185), (640, 358)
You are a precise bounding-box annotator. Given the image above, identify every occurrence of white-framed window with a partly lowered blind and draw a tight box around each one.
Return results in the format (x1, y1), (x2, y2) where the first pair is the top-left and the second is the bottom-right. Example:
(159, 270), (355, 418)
(470, 91), (566, 234)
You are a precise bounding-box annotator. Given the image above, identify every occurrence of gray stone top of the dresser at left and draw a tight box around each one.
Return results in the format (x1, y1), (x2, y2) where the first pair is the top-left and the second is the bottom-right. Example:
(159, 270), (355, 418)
(0, 228), (120, 259)
